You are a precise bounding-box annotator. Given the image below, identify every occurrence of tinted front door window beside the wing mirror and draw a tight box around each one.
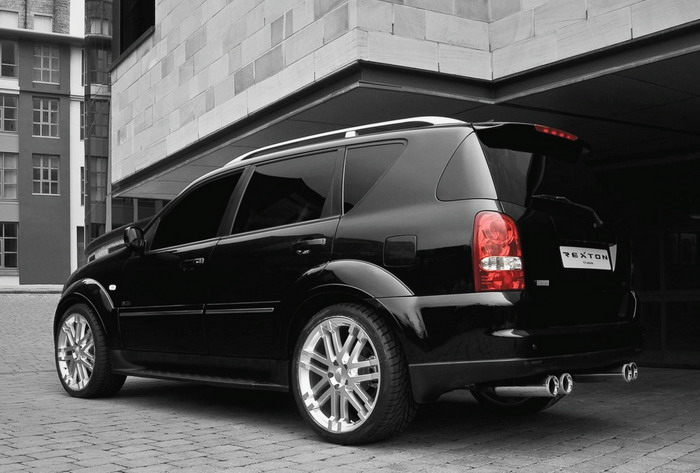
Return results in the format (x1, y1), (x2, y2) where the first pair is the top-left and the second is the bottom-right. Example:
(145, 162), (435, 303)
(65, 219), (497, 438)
(151, 172), (241, 250)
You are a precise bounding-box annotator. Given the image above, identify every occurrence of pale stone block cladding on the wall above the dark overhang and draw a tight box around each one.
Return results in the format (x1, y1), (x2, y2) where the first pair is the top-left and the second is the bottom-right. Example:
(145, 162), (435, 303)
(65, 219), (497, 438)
(112, 0), (700, 184)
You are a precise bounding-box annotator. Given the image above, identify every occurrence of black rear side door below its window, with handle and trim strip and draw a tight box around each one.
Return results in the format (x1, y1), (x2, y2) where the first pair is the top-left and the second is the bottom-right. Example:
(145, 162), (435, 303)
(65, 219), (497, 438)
(204, 217), (339, 358)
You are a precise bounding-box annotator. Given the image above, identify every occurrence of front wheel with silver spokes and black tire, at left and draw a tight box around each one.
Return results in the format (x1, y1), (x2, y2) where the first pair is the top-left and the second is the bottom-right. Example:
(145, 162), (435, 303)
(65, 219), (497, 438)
(54, 304), (126, 398)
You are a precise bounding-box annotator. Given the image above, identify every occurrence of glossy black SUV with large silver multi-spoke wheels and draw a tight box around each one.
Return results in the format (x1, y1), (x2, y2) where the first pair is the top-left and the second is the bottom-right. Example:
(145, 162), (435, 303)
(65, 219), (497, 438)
(54, 117), (641, 444)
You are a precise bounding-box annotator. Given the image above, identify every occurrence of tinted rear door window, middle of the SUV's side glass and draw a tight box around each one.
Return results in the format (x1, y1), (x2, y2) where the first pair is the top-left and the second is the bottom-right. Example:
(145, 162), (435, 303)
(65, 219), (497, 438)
(233, 150), (339, 233)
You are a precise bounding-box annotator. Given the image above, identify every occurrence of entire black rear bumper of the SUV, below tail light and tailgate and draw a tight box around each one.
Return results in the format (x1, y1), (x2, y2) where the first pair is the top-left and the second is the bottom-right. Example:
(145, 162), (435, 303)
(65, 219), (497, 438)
(379, 292), (642, 402)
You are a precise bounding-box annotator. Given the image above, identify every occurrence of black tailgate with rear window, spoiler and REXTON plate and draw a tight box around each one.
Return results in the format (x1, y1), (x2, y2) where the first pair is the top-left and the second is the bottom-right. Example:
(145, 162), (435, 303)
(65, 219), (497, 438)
(477, 124), (632, 327)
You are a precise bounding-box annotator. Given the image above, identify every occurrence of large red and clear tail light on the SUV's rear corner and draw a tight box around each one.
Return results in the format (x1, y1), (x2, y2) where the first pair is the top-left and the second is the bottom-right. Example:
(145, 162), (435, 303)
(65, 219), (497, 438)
(472, 211), (525, 291)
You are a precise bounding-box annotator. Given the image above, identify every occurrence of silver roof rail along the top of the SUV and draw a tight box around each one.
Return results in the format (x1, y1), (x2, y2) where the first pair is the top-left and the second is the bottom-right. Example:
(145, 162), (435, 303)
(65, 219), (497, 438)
(224, 117), (465, 167)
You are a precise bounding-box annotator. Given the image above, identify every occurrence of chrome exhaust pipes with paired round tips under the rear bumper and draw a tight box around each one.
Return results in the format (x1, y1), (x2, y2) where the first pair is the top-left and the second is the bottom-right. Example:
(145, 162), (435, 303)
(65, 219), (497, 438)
(484, 362), (639, 397)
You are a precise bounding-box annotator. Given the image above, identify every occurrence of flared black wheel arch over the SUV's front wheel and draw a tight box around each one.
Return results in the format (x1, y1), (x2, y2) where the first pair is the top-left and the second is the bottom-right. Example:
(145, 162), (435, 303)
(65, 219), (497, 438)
(54, 278), (119, 347)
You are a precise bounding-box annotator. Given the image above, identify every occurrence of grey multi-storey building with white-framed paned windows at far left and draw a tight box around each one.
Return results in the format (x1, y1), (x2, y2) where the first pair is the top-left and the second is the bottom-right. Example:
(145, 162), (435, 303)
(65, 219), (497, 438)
(0, 0), (84, 285)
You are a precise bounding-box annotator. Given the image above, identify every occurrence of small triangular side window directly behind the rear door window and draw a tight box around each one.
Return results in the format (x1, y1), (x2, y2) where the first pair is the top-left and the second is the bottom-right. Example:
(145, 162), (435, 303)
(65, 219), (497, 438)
(343, 143), (406, 212)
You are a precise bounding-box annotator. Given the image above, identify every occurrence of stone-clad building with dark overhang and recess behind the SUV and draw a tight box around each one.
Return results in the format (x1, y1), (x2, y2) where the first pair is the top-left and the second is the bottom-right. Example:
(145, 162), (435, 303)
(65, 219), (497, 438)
(110, 0), (700, 366)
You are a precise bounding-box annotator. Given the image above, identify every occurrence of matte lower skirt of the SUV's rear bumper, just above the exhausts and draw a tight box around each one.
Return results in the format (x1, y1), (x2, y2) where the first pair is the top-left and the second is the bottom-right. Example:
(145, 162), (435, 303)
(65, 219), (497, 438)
(408, 347), (639, 402)
